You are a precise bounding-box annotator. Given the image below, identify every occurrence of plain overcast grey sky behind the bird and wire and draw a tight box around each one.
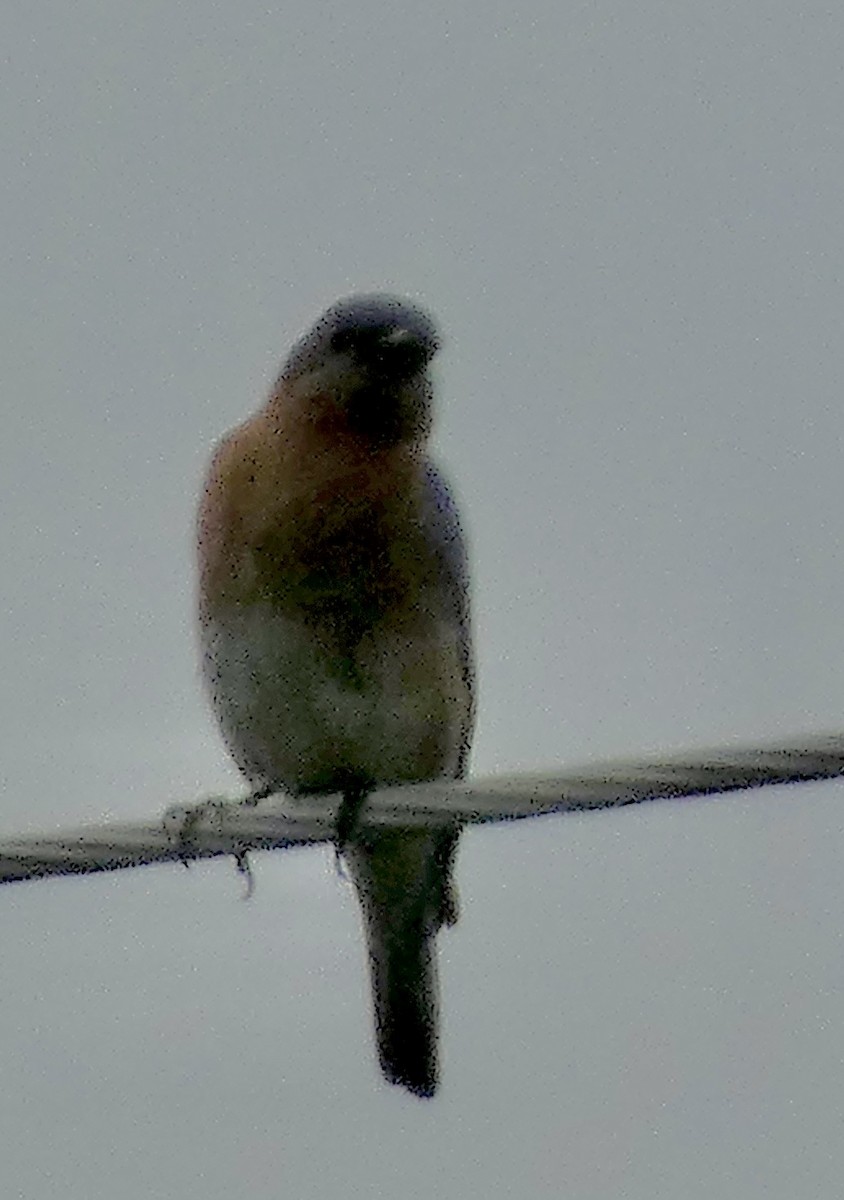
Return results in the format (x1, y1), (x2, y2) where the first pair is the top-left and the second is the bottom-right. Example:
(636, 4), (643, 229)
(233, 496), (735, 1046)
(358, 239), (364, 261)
(0, 0), (844, 1200)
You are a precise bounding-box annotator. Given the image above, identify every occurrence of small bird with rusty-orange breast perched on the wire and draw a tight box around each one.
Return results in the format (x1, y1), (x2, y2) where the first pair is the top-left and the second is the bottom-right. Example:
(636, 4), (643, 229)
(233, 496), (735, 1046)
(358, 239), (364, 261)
(197, 293), (475, 1098)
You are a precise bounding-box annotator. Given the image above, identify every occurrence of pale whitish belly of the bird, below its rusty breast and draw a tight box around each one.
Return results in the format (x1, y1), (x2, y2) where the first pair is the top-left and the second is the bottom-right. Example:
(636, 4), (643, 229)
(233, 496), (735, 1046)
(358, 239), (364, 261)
(203, 605), (469, 792)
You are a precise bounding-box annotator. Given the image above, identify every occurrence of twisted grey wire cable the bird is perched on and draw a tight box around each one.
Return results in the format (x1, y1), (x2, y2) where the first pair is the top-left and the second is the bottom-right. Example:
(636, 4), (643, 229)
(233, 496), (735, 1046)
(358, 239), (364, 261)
(0, 736), (844, 883)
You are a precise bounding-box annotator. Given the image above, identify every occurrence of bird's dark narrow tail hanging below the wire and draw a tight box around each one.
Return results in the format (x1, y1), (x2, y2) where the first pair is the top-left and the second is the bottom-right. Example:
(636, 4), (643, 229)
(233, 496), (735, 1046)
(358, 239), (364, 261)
(347, 829), (456, 1097)
